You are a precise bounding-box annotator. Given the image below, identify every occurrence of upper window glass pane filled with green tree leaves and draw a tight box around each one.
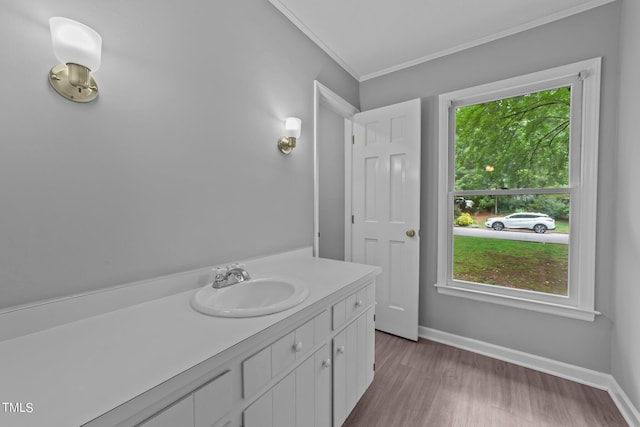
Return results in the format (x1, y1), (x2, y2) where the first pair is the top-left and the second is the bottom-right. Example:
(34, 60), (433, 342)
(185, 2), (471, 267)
(455, 86), (571, 190)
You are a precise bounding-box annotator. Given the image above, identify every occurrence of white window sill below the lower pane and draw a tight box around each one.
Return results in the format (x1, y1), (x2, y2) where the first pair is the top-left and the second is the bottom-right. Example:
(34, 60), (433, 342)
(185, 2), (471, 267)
(435, 284), (601, 322)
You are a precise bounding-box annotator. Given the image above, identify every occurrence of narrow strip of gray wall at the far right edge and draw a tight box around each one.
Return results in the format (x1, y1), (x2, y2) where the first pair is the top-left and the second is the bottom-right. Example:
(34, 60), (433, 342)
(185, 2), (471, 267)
(611, 0), (640, 408)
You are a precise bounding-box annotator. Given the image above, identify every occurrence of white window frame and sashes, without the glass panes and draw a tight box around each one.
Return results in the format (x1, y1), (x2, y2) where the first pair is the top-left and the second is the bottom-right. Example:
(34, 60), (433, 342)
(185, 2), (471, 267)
(435, 57), (602, 322)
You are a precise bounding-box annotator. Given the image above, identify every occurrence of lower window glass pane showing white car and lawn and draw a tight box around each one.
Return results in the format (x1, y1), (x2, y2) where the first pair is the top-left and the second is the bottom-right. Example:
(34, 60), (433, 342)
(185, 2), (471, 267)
(453, 194), (569, 295)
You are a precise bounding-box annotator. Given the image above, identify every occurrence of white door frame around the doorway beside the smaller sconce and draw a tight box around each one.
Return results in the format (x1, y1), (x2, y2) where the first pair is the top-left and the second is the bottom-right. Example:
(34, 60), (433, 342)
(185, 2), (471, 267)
(313, 80), (360, 261)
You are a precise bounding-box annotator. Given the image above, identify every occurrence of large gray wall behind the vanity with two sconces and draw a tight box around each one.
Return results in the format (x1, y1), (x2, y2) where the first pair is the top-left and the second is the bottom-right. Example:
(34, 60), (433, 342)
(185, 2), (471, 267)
(0, 0), (359, 308)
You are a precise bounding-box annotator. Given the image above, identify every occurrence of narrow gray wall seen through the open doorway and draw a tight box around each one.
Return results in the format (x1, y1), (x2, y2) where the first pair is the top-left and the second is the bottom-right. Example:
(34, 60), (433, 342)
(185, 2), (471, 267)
(318, 104), (345, 261)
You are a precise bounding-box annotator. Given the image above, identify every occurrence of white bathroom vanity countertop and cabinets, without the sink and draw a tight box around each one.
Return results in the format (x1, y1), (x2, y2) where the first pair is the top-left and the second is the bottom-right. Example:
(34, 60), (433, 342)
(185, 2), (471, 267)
(0, 251), (380, 427)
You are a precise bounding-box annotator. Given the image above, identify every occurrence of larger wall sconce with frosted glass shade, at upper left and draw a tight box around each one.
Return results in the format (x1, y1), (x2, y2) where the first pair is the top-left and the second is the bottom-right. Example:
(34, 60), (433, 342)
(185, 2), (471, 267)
(49, 17), (102, 102)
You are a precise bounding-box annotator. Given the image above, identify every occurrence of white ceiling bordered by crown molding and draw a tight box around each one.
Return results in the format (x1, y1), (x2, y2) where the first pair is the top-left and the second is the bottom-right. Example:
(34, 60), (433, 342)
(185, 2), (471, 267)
(269, 0), (615, 81)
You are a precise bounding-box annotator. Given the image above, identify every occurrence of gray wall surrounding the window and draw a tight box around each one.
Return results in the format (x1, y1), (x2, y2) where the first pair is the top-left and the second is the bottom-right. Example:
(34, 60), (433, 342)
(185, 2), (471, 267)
(360, 2), (620, 372)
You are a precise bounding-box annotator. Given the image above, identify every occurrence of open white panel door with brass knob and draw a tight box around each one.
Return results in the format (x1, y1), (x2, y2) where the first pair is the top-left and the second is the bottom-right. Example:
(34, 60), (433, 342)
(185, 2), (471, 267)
(351, 99), (420, 341)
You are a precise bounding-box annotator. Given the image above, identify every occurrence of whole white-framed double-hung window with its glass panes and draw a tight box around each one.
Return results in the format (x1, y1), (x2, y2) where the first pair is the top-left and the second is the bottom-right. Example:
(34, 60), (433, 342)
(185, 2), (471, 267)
(436, 58), (601, 321)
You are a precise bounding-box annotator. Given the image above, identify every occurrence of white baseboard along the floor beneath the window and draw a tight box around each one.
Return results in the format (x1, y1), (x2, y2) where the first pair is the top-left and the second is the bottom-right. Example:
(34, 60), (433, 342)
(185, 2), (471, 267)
(418, 326), (640, 427)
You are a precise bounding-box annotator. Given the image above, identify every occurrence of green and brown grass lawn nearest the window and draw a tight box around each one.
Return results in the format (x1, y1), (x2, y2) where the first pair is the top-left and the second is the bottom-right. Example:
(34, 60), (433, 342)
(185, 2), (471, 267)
(453, 236), (569, 295)
